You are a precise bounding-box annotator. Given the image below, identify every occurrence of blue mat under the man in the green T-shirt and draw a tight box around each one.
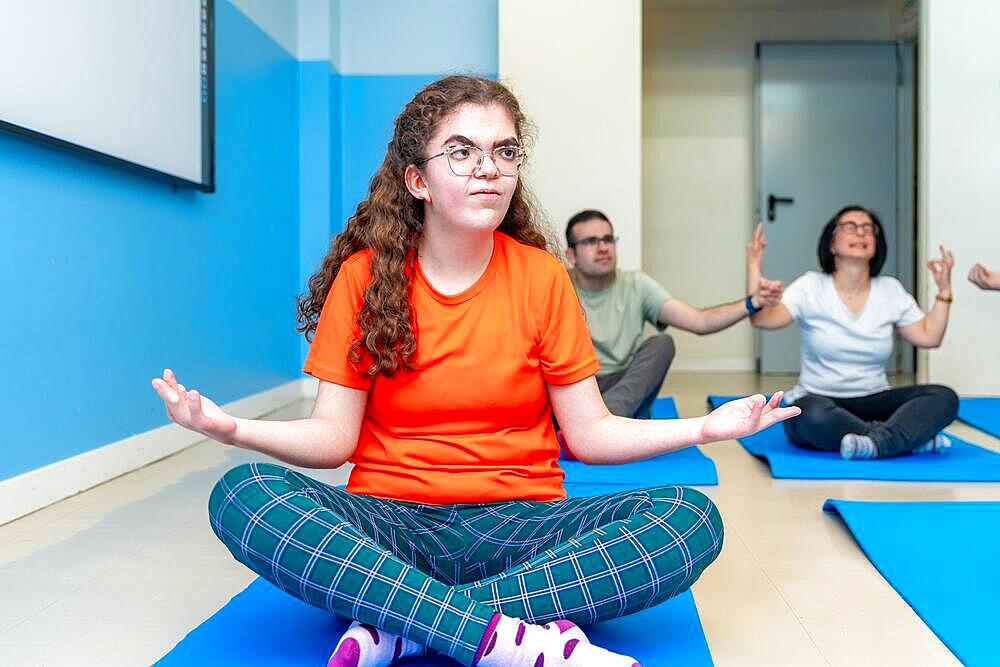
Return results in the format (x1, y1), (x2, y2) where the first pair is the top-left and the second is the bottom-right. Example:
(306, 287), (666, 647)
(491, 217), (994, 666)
(559, 397), (719, 487)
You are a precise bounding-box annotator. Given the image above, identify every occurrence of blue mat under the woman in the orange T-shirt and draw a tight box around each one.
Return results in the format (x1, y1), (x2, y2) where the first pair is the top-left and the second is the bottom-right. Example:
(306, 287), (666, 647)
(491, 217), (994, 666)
(156, 484), (713, 667)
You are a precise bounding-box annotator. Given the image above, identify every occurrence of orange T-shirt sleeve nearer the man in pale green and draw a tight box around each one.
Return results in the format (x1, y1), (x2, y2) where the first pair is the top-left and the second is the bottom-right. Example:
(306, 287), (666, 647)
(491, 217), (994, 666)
(532, 262), (600, 385)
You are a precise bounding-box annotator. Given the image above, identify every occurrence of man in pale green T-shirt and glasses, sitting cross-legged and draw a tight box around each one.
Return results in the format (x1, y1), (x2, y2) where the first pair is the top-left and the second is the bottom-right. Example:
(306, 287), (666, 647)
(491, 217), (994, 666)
(566, 210), (783, 417)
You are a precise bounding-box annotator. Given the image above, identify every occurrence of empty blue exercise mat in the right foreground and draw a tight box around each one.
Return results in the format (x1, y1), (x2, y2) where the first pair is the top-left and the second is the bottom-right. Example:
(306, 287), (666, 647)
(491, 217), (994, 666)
(823, 500), (1000, 667)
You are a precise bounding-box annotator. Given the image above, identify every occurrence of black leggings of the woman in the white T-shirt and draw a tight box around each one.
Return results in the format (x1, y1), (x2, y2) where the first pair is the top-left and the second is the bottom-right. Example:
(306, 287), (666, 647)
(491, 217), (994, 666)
(784, 384), (958, 457)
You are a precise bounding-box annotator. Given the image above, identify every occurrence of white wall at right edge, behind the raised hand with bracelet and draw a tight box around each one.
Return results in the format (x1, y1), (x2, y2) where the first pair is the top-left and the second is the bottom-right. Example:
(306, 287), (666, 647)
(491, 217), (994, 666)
(918, 0), (1000, 394)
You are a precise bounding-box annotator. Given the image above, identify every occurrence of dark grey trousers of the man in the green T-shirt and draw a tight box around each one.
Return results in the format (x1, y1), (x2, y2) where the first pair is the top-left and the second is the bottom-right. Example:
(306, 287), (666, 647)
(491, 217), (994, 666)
(597, 334), (675, 419)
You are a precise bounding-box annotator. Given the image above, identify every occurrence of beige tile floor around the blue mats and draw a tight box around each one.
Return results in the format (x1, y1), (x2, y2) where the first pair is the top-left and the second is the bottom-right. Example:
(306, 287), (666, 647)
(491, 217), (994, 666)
(0, 373), (1000, 667)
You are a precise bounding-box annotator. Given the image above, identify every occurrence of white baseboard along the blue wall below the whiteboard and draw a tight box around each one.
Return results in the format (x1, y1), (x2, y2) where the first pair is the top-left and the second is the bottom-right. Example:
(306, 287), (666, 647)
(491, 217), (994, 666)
(0, 378), (318, 525)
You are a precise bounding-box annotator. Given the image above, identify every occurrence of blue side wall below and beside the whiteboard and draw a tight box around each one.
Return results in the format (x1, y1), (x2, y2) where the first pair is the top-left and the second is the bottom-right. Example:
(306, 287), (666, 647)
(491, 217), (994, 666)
(0, 2), (300, 479)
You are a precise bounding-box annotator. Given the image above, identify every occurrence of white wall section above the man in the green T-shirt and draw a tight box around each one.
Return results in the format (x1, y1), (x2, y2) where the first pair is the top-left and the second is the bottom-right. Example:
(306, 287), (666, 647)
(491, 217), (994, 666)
(498, 0), (642, 268)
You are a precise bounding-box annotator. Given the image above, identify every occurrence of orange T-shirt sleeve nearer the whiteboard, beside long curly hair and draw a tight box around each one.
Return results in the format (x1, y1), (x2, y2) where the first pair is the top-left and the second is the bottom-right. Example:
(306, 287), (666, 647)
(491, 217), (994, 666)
(302, 253), (372, 390)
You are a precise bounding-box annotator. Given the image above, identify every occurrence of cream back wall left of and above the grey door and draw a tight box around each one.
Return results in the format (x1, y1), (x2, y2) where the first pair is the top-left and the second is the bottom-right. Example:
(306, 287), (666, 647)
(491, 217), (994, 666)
(642, 2), (896, 370)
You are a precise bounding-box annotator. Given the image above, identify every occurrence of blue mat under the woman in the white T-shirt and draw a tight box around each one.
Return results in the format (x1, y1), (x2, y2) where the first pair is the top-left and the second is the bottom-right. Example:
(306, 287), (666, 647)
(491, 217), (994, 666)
(708, 396), (1000, 482)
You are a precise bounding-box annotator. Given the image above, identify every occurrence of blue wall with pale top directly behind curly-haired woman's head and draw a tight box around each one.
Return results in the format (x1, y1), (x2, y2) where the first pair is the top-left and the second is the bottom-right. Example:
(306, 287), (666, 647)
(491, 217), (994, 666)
(300, 0), (499, 318)
